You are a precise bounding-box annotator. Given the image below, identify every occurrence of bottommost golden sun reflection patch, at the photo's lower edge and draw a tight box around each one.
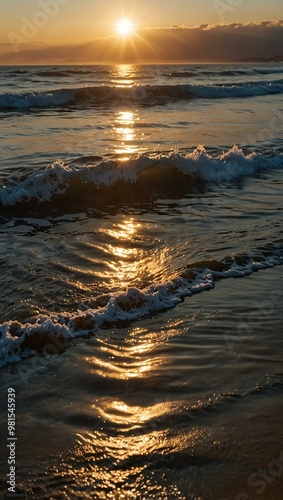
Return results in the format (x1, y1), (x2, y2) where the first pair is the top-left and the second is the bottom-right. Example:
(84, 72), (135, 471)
(65, 422), (204, 500)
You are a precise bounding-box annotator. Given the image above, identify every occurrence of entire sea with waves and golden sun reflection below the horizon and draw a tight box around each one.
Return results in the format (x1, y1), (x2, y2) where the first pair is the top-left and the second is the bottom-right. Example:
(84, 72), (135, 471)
(0, 62), (283, 500)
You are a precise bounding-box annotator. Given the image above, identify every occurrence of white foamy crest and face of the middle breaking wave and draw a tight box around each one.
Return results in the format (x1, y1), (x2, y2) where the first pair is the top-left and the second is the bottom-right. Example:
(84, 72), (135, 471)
(0, 146), (283, 206)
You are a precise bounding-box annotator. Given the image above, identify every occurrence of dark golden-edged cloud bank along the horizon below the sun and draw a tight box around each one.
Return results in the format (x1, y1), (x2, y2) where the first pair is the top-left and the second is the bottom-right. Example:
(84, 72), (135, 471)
(0, 20), (283, 64)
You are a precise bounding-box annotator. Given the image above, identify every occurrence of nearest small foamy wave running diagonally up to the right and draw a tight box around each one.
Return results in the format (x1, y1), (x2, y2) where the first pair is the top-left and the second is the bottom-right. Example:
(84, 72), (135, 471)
(0, 242), (283, 367)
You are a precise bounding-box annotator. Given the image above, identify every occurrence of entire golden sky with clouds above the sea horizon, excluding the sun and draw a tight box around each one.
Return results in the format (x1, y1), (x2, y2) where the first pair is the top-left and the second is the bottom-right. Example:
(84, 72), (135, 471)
(0, 0), (283, 64)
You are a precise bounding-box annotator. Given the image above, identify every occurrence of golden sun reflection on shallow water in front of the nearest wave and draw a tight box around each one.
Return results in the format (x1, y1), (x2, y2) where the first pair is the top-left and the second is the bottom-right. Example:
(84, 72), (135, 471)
(66, 320), (200, 499)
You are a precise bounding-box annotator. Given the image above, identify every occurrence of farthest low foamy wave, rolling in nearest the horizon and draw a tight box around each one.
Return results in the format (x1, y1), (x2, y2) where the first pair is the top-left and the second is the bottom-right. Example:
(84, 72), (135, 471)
(0, 80), (283, 110)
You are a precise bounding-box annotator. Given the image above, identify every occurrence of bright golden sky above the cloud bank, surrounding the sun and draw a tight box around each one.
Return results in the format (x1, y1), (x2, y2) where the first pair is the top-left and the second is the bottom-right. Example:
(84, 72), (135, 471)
(0, 0), (282, 43)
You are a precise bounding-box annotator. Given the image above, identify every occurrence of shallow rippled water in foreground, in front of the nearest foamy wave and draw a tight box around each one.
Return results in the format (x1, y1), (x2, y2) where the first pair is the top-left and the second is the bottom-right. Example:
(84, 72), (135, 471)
(1, 269), (283, 500)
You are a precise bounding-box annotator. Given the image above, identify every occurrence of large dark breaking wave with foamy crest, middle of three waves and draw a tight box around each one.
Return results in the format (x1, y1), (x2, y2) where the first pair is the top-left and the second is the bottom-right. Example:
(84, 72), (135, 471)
(0, 146), (283, 209)
